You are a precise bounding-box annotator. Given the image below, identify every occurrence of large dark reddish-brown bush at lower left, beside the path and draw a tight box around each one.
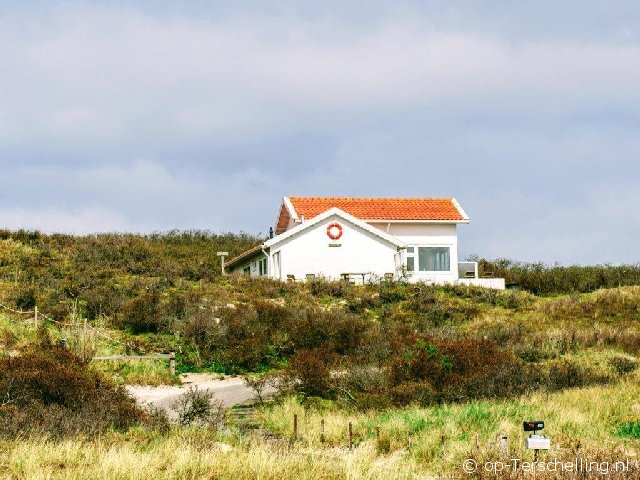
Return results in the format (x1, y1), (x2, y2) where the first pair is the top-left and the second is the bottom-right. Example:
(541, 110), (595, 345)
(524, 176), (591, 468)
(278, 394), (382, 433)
(0, 342), (145, 437)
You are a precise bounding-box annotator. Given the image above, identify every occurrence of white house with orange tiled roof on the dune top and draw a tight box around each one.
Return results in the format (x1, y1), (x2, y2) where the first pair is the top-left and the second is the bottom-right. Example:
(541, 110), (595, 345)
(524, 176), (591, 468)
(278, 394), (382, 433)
(227, 197), (505, 289)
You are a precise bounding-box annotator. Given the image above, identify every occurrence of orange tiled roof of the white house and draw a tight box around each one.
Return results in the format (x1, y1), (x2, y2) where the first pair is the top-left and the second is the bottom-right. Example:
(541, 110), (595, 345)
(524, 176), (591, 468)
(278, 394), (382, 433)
(288, 197), (466, 221)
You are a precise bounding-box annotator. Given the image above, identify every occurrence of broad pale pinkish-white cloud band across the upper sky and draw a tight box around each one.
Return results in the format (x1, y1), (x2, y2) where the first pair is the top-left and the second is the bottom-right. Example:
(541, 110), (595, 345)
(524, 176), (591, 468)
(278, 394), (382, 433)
(0, 8), (640, 148)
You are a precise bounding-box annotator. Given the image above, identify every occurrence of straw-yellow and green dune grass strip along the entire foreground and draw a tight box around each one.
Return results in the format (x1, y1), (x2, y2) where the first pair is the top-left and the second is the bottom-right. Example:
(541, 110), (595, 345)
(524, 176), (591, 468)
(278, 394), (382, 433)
(0, 375), (640, 480)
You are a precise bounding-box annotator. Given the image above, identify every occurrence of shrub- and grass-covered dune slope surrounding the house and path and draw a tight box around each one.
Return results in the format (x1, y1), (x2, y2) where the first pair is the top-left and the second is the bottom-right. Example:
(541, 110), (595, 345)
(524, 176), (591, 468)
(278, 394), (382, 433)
(0, 231), (640, 478)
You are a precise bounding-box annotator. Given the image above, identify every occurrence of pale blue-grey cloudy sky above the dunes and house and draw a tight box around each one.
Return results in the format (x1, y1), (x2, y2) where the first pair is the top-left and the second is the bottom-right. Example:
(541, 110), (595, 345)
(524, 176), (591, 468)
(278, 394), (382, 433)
(0, 0), (640, 264)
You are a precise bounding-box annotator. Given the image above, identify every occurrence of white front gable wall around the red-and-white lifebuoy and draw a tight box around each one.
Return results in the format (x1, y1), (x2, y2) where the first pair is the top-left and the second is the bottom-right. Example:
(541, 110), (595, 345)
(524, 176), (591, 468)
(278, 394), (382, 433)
(270, 215), (398, 280)
